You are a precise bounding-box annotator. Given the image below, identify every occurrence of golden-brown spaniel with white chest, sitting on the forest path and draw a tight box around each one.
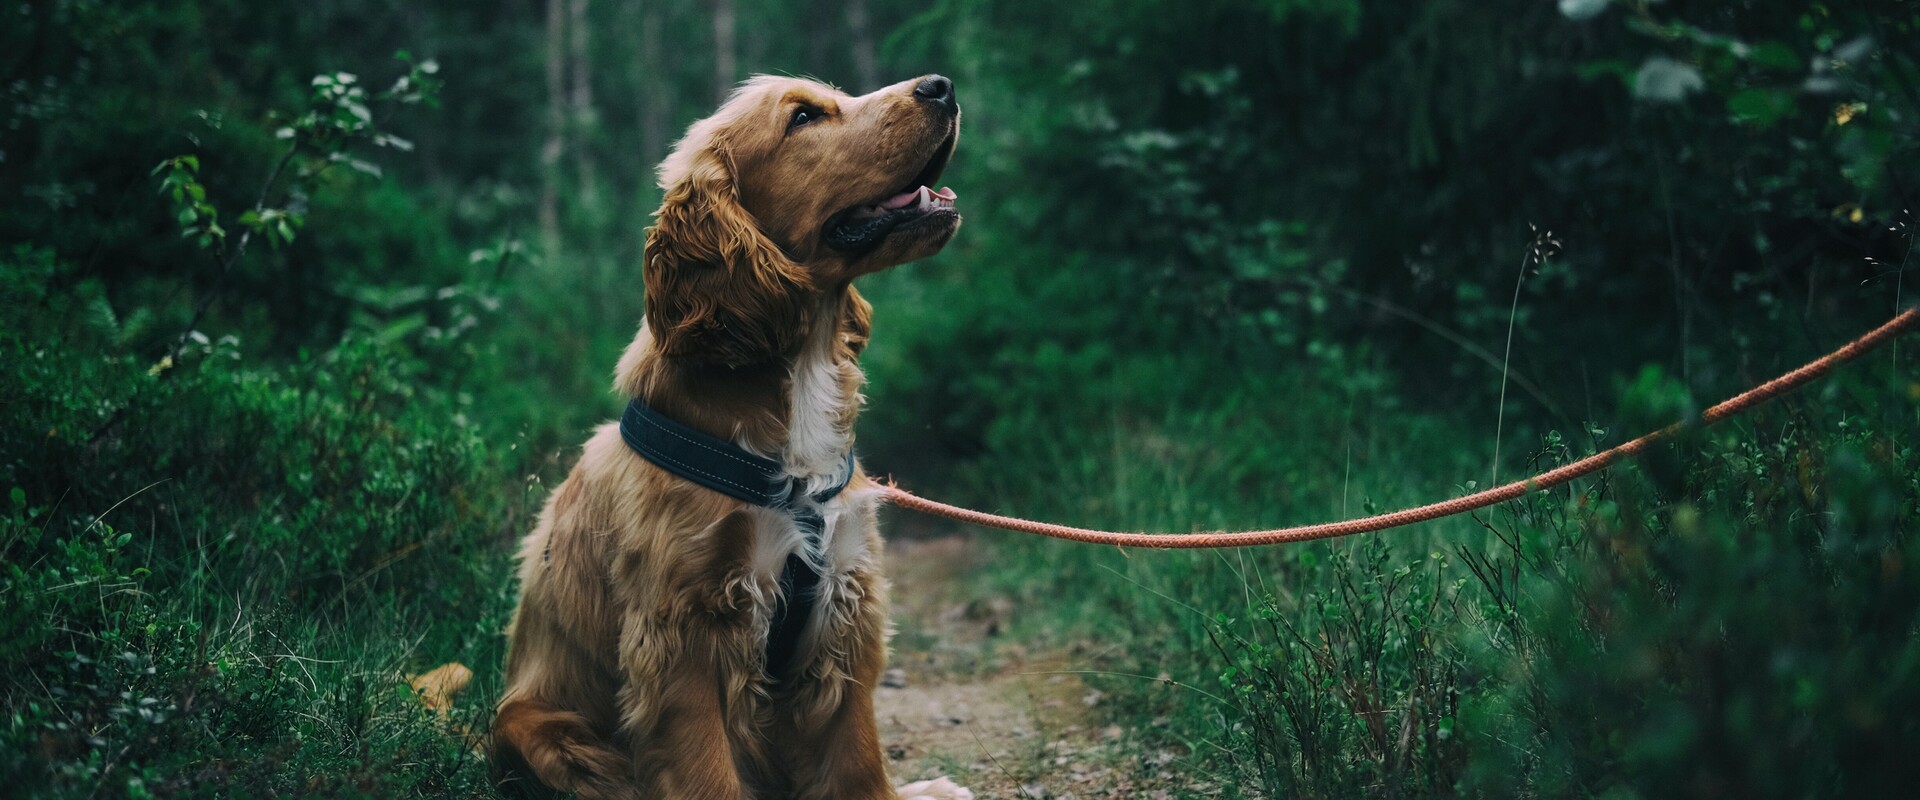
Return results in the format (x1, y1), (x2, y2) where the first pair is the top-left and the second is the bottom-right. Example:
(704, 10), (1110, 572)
(490, 75), (972, 800)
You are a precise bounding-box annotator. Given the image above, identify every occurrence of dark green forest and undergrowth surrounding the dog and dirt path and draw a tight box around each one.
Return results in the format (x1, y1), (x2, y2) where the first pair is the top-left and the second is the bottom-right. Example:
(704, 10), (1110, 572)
(0, 0), (1920, 798)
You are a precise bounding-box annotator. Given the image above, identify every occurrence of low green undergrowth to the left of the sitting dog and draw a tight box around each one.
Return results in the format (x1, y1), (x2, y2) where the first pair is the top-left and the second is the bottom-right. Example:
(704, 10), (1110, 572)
(0, 249), (524, 796)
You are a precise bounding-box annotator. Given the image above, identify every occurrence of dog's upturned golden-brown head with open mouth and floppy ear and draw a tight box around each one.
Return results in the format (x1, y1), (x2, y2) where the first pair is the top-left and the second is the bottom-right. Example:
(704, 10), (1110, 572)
(645, 75), (960, 366)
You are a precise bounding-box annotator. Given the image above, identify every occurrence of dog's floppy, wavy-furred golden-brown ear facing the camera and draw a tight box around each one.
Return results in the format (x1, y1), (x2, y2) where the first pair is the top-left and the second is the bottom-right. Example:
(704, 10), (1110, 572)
(645, 143), (812, 366)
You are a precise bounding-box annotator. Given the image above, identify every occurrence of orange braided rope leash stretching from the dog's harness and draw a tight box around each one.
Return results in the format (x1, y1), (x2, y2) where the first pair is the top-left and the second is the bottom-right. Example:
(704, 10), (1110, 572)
(881, 309), (1920, 549)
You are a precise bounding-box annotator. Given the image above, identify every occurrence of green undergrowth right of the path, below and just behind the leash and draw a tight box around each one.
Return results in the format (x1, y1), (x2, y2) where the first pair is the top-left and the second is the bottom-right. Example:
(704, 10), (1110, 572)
(917, 328), (1920, 798)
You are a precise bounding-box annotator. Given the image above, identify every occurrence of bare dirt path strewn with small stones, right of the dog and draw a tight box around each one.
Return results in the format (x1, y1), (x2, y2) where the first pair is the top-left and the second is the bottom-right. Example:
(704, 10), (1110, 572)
(874, 535), (1212, 800)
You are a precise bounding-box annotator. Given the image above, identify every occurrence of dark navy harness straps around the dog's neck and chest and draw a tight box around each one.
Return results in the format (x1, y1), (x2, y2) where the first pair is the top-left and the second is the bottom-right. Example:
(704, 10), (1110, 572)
(620, 399), (852, 677)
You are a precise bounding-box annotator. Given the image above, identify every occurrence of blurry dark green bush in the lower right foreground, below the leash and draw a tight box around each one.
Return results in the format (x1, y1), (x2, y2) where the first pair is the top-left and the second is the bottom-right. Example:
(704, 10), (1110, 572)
(1465, 423), (1920, 796)
